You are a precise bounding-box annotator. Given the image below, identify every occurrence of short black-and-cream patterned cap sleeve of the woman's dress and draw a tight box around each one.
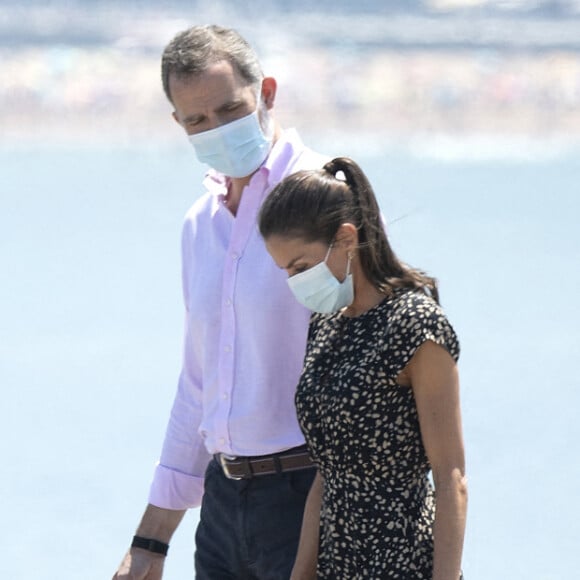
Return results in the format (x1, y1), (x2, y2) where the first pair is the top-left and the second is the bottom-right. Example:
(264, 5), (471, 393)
(388, 292), (459, 375)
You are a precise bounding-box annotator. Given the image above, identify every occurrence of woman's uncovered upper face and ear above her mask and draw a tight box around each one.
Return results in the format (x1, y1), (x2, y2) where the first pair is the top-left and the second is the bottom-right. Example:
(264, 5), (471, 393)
(266, 235), (348, 282)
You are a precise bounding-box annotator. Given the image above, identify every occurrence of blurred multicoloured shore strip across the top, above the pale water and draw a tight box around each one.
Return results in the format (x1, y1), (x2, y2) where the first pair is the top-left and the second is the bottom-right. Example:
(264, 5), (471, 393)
(0, 0), (580, 142)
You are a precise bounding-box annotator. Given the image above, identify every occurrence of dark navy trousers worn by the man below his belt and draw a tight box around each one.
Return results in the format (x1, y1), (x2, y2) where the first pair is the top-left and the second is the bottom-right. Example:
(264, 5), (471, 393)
(195, 459), (316, 580)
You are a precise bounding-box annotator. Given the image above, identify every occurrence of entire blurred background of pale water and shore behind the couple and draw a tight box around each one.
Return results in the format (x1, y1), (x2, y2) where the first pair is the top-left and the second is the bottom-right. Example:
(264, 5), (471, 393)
(0, 0), (580, 580)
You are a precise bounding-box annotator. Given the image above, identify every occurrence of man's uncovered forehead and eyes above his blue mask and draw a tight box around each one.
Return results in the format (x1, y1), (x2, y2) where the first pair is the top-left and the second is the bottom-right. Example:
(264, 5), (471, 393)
(169, 60), (257, 135)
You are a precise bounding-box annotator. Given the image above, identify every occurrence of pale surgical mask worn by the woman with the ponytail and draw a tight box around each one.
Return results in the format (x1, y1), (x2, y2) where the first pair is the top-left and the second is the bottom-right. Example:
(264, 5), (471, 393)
(288, 246), (354, 314)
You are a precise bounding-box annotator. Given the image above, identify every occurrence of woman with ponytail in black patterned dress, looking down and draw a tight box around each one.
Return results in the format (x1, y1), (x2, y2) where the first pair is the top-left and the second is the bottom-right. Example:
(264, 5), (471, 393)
(259, 158), (467, 580)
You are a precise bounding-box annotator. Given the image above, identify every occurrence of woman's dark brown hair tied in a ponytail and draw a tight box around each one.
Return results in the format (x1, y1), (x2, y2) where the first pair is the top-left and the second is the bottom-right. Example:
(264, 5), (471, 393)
(258, 157), (439, 302)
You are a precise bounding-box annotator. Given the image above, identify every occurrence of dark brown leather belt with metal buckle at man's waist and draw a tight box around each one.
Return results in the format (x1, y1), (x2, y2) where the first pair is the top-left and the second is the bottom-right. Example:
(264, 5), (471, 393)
(215, 445), (314, 479)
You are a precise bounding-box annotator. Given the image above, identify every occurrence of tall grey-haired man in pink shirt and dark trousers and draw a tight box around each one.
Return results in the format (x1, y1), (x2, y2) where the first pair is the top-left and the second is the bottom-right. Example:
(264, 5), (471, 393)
(114, 26), (327, 580)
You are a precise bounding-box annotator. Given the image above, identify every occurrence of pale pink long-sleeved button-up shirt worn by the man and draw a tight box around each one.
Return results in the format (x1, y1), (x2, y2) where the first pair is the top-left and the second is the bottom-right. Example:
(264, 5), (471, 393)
(149, 130), (328, 509)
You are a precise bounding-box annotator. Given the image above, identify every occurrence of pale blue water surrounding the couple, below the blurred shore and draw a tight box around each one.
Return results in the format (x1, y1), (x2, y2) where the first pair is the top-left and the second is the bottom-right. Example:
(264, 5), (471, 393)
(0, 137), (580, 580)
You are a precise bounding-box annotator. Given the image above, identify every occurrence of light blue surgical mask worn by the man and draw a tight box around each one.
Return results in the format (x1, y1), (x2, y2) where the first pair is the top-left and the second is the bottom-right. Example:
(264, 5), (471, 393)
(189, 102), (273, 177)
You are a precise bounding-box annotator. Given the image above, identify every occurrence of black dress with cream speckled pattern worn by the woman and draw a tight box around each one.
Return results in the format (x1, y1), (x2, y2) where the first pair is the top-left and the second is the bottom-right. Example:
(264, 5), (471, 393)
(296, 290), (459, 580)
